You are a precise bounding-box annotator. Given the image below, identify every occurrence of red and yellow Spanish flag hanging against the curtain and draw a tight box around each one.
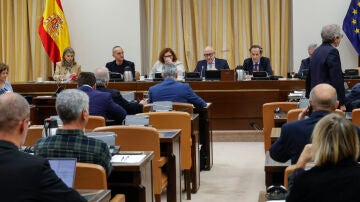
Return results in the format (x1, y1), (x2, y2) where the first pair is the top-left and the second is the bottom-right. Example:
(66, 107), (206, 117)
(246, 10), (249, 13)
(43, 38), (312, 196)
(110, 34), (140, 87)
(38, 0), (70, 63)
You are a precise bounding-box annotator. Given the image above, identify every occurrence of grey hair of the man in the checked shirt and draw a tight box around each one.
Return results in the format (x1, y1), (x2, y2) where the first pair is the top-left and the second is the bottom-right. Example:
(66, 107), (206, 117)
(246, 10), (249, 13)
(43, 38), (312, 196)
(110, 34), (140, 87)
(56, 89), (89, 124)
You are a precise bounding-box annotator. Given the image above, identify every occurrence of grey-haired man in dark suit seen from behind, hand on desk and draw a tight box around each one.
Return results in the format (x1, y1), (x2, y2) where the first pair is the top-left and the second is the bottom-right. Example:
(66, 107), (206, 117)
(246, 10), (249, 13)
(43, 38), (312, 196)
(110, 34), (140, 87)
(95, 67), (147, 114)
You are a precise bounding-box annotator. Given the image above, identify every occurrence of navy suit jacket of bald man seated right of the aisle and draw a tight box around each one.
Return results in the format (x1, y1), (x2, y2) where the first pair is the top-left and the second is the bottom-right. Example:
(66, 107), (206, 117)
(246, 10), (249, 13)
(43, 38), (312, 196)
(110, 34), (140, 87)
(269, 111), (329, 164)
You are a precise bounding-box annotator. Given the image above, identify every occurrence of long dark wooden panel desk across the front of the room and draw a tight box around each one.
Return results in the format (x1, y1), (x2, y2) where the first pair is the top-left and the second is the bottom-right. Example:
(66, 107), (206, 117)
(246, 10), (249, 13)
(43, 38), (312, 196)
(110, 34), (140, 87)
(12, 79), (360, 130)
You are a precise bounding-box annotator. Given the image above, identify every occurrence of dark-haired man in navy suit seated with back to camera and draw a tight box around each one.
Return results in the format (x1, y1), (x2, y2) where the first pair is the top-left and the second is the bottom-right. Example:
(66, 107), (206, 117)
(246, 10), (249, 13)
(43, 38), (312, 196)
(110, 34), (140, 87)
(78, 72), (126, 124)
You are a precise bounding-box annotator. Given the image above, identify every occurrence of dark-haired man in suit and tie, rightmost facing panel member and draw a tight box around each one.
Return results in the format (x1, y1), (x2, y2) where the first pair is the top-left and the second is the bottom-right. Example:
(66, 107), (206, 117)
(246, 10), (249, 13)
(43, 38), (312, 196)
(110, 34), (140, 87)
(243, 45), (272, 75)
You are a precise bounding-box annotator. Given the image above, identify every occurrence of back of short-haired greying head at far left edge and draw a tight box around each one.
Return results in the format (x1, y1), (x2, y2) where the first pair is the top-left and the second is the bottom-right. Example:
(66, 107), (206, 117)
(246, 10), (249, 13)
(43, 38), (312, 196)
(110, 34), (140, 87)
(0, 92), (30, 132)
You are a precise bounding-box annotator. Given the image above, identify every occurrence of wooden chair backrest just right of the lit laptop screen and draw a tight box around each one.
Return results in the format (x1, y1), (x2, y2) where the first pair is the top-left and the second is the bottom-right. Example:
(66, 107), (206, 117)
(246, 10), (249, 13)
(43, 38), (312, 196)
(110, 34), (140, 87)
(74, 162), (107, 189)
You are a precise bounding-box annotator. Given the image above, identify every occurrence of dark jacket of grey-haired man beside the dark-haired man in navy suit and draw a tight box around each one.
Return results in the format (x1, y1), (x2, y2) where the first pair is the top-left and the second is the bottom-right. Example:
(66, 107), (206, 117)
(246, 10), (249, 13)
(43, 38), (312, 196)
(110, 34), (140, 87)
(96, 87), (143, 114)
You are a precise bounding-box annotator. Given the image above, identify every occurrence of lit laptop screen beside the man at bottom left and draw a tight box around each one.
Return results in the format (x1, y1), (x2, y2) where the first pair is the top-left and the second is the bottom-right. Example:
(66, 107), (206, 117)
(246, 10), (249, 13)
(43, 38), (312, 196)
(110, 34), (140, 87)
(48, 158), (76, 188)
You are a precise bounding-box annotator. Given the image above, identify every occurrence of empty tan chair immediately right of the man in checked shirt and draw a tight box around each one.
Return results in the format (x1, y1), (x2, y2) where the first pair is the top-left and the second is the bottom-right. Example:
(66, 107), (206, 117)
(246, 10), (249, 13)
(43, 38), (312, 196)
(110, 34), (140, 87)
(93, 125), (168, 201)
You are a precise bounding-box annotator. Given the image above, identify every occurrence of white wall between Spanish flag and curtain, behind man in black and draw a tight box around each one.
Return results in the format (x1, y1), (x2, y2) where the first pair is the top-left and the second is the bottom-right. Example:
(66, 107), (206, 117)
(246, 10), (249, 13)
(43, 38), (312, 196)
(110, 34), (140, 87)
(61, 0), (141, 71)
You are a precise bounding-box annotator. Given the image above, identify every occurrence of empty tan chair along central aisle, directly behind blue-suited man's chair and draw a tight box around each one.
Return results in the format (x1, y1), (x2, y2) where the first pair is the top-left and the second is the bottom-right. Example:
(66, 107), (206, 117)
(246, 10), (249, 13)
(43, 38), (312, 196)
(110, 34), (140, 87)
(141, 111), (192, 200)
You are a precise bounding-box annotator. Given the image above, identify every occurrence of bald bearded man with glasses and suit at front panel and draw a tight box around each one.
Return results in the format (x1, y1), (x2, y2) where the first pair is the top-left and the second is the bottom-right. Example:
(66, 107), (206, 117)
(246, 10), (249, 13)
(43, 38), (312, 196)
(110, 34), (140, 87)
(194, 46), (229, 77)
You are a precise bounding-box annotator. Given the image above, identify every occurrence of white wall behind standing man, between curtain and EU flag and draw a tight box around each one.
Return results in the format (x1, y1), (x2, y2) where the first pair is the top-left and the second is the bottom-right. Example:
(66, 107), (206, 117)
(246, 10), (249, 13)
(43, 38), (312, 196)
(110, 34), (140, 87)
(290, 0), (358, 72)
